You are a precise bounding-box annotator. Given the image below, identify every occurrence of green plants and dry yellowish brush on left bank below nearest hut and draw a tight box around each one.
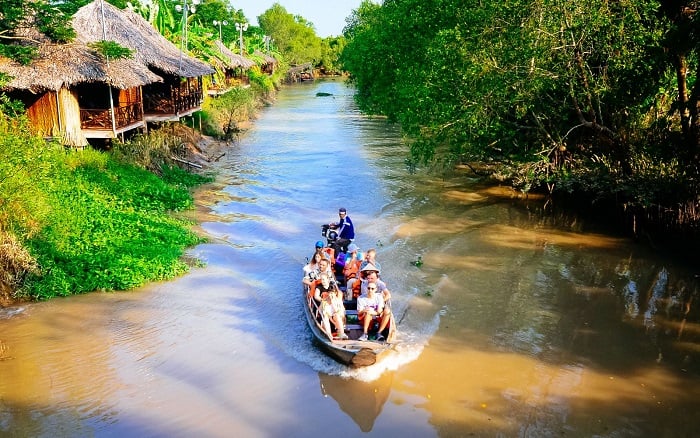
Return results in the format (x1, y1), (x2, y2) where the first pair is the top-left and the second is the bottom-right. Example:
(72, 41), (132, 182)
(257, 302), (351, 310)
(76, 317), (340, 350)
(0, 105), (208, 299)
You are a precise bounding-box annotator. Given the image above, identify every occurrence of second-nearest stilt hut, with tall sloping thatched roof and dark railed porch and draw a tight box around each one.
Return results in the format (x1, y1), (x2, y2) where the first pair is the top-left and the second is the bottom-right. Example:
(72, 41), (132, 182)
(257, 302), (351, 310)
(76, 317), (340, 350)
(72, 0), (215, 122)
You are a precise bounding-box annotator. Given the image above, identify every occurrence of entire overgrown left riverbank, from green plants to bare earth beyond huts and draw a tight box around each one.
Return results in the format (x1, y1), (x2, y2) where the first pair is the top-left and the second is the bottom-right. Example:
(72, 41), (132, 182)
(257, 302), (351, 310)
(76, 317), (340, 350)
(0, 81), (276, 307)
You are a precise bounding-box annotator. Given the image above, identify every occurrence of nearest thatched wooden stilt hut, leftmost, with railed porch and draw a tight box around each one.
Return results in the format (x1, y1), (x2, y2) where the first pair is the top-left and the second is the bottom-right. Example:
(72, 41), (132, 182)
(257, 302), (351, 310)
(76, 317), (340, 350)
(0, 41), (161, 147)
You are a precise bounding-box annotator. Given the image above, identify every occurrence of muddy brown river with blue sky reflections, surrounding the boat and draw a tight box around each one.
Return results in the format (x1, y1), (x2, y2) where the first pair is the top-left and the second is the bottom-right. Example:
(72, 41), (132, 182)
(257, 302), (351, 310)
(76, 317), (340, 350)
(0, 80), (700, 437)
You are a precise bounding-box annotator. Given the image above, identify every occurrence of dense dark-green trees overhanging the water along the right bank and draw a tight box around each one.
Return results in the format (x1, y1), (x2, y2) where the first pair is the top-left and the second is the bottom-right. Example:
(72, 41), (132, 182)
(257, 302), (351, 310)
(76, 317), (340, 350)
(342, 0), (700, 233)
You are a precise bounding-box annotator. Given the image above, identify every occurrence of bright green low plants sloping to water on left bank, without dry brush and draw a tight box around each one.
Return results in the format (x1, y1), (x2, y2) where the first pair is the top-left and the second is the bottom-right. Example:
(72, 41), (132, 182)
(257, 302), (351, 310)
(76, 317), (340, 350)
(25, 152), (208, 299)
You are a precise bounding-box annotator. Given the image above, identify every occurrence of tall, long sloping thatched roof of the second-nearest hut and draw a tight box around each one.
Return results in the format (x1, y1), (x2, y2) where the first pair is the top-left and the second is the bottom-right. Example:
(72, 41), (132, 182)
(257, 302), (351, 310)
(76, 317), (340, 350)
(72, 0), (214, 78)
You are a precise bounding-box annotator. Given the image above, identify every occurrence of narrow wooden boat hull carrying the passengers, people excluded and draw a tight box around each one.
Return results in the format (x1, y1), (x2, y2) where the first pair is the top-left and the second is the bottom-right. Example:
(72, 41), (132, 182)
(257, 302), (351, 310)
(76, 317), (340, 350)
(302, 233), (396, 367)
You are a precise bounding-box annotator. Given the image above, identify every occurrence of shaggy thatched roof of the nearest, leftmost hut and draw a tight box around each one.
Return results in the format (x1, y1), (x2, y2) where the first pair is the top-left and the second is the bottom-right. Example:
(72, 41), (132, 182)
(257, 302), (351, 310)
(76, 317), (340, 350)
(0, 43), (162, 93)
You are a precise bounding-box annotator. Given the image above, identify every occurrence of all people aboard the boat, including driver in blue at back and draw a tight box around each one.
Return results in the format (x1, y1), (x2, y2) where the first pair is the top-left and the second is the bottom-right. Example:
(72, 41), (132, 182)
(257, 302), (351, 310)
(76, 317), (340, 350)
(302, 208), (391, 341)
